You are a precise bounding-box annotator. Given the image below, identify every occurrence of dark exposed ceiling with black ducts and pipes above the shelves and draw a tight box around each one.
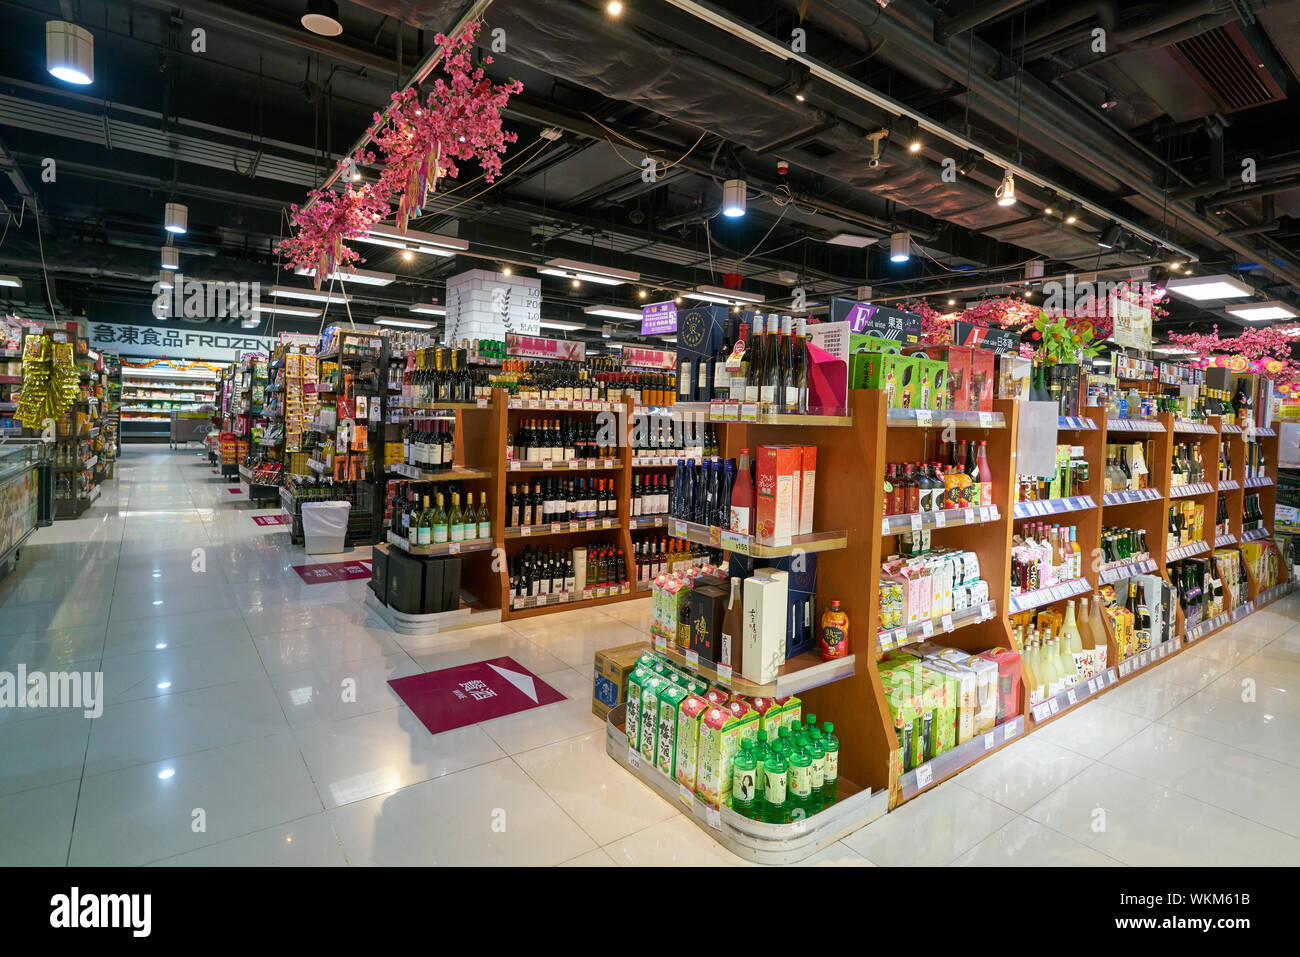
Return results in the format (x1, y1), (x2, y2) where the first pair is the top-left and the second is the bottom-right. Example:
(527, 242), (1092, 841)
(0, 0), (1300, 348)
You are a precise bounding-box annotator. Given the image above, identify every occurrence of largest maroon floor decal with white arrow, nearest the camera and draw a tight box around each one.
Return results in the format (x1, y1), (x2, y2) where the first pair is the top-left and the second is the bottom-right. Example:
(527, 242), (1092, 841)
(389, 658), (566, 735)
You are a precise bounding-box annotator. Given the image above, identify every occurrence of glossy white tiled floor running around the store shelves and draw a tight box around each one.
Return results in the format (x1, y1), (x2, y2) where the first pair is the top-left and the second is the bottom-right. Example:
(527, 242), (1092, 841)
(0, 446), (1300, 866)
